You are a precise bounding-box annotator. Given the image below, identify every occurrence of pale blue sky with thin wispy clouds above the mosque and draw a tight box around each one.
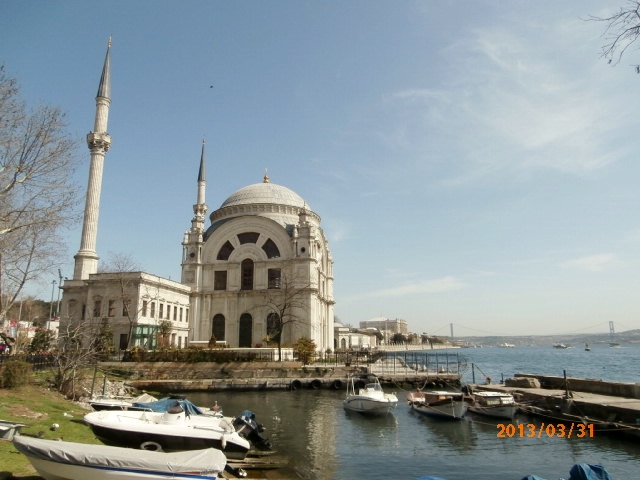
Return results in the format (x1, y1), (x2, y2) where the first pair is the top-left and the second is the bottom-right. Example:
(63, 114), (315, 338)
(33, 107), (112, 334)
(0, 0), (640, 336)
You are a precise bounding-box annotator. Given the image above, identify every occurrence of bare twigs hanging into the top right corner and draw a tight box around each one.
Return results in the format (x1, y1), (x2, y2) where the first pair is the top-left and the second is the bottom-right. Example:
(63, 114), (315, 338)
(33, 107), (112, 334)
(589, 0), (640, 73)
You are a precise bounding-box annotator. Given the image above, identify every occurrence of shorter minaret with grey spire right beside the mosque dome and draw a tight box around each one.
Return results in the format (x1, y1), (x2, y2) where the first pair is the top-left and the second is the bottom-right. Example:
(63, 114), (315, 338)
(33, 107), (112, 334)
(182, 140), (208, 288)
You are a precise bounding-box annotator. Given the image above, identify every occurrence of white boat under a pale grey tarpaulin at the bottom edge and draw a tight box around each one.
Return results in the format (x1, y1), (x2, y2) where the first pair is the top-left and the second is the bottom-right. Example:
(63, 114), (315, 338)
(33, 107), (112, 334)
(13, 435), (227, 480)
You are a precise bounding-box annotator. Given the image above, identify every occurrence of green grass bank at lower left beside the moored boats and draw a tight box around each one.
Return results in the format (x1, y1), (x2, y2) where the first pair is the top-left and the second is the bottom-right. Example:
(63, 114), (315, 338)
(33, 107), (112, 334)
(0, 385), (100, 480)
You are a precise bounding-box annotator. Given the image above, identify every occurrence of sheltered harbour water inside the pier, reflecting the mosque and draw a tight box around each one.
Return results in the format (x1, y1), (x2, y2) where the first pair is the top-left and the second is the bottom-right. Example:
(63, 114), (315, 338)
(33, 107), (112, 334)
(189, 389), (640, 480)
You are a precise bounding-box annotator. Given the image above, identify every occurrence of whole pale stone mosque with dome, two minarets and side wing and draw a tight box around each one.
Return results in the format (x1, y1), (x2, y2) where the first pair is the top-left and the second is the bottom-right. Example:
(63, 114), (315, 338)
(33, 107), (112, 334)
(60, 41), (336, 351)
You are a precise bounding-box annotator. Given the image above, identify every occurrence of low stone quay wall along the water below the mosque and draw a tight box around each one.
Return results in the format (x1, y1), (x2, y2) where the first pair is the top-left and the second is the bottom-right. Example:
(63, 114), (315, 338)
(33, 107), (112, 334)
(100, 362), (460, 392)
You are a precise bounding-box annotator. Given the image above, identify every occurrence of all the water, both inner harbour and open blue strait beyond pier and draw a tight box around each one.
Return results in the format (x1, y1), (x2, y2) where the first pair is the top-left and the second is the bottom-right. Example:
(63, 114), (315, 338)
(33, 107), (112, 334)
(189, 345), (640, 480)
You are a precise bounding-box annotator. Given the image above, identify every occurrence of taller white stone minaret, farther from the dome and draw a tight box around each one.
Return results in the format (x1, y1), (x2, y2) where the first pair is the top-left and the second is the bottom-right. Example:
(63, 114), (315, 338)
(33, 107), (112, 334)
(73, 38), (111, 280)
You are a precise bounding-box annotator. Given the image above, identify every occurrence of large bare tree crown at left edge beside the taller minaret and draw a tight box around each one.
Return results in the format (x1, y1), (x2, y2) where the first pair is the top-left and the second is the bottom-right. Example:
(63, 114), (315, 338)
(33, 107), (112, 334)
(0, 66), (80, 322)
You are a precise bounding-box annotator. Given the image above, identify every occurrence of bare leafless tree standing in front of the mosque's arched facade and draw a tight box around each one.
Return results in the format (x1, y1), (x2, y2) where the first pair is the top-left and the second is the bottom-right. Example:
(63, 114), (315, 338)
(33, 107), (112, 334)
(265, 269), (310, 361)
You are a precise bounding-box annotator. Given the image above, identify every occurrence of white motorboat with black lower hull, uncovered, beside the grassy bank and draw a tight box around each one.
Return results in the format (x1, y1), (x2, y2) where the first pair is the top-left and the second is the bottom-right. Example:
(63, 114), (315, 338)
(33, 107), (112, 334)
(84, 405), (251, 460)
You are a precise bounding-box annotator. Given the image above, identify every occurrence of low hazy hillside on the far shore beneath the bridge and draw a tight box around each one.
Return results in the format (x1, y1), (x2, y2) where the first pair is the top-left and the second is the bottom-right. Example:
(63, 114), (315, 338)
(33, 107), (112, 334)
(454, 329), (640, 347)
